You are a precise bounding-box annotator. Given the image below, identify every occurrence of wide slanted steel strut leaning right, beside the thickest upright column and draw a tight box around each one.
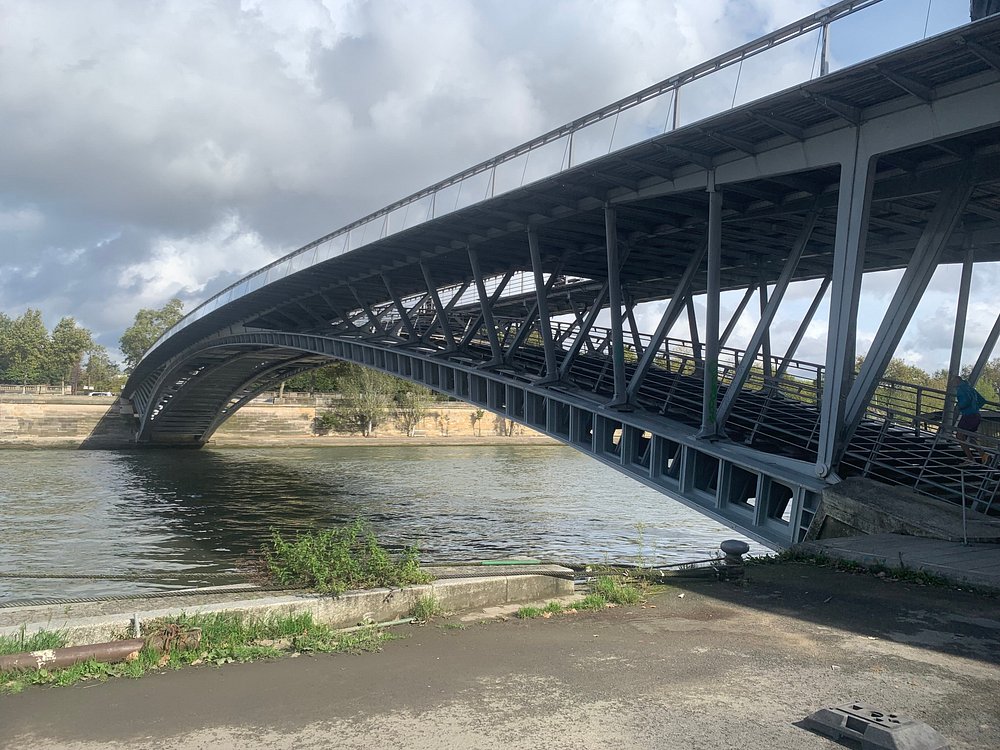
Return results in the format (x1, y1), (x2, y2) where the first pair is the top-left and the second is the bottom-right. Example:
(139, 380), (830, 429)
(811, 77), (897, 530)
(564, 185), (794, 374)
(835, 175), (973, 450)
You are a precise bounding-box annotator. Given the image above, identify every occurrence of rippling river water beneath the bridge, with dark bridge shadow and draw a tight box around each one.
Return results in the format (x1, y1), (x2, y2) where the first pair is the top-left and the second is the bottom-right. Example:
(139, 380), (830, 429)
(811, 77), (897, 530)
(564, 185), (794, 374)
(0, 446), (766, 604)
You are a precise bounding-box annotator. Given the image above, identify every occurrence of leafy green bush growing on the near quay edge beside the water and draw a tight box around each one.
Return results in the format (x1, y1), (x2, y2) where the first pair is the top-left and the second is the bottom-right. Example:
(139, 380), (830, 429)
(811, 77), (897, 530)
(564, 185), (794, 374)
(260, 520), (431, 595)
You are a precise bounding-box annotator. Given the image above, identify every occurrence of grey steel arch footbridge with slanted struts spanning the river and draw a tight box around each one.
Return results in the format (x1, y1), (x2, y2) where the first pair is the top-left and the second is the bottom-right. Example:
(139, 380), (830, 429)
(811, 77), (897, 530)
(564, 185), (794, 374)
(125, 0), (1000, 546)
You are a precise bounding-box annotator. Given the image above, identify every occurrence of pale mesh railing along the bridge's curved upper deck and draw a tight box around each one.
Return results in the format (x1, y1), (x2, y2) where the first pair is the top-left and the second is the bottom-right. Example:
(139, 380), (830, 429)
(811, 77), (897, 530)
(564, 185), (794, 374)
(141, 0), (964, 362)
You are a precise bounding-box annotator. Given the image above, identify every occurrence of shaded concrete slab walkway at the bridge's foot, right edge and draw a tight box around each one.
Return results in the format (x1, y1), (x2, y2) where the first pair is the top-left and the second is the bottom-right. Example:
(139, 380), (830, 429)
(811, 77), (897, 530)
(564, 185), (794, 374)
(797, 534), (1000, 592)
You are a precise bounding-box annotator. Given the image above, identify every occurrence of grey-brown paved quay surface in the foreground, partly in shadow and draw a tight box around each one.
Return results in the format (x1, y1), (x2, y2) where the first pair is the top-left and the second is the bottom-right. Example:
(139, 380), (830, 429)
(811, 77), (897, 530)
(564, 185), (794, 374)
(0, 563), (1000, 750)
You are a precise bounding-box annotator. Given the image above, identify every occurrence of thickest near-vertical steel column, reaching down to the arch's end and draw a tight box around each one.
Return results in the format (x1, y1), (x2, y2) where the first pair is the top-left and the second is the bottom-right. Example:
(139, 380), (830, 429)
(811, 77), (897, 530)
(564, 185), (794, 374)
(816, 142), (875, 477)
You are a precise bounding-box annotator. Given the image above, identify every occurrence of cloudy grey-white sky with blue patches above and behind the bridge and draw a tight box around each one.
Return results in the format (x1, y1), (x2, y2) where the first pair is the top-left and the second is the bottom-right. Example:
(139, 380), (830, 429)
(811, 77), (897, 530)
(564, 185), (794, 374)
(0, 0), (995, 376)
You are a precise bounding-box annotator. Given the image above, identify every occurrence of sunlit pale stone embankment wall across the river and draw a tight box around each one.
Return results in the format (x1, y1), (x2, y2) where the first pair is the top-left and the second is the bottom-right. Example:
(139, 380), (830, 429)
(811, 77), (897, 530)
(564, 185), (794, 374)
(0, 393), (555, 448)
